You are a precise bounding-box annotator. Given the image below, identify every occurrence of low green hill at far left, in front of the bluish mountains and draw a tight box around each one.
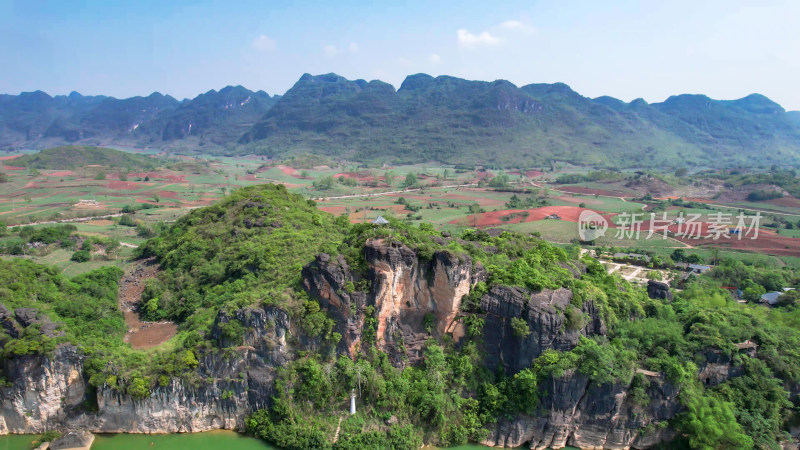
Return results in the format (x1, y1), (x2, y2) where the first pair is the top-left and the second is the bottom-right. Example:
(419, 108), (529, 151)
(14, 145), (159, 170)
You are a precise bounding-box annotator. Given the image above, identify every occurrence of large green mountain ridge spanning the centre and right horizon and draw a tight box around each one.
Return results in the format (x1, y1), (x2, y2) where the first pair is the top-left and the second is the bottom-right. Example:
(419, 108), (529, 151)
(240, 74), (800, 167)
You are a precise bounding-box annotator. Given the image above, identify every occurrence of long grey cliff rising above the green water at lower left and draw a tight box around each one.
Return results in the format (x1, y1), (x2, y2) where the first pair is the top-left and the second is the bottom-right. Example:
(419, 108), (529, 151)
(0, 308), (291, 434)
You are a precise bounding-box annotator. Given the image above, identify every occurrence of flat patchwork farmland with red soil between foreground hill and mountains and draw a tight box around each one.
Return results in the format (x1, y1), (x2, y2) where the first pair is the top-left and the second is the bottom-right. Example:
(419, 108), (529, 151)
(0, 148), (800, 275)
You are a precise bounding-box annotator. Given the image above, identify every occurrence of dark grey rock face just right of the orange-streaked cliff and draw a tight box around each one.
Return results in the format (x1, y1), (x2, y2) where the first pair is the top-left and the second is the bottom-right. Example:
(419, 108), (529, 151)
(481, 286), (606, 374)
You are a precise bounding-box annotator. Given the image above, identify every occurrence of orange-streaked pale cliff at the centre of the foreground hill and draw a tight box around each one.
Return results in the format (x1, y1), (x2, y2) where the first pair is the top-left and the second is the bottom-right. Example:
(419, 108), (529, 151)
(303, 241), (485, 365)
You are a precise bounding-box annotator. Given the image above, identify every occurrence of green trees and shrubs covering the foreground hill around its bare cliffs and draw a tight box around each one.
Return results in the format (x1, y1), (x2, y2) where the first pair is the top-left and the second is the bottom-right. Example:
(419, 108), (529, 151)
(0, 181), (800, 449)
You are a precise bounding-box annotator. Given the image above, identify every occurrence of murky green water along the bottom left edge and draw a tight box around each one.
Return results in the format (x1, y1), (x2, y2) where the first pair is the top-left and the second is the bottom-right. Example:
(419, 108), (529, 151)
(0, 431), (571, 450)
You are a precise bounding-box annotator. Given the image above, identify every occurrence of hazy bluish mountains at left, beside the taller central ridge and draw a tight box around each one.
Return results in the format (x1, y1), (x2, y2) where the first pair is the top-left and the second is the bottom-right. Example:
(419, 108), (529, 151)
(0, 86), (279, 152)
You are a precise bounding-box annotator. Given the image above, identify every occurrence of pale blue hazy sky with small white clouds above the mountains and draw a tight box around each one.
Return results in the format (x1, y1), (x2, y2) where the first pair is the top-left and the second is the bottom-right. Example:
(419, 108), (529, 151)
(0, 0), (800, 110)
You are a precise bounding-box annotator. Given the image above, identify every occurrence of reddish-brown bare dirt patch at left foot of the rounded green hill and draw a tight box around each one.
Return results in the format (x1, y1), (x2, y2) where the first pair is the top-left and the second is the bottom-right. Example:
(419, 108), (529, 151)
(119, 259), (178, 349)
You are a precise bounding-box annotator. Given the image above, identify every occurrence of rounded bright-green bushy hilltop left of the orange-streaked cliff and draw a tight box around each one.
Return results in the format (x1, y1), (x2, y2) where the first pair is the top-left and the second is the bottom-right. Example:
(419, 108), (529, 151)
(140, 185), (347, 326)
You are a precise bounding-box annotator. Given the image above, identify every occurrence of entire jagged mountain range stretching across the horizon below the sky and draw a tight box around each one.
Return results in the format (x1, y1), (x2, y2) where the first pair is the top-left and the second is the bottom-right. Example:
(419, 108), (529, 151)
(0, 74), (800, 167)
